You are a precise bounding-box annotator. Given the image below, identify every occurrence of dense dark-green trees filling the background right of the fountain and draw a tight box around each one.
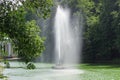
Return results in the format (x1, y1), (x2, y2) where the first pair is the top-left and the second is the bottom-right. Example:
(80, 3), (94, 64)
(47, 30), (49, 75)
(61, 0), (120, 62)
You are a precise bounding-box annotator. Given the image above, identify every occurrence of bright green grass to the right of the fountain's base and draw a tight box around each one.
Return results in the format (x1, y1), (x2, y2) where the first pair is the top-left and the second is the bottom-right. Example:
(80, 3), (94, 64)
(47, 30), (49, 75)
(79, 64), (120, 80)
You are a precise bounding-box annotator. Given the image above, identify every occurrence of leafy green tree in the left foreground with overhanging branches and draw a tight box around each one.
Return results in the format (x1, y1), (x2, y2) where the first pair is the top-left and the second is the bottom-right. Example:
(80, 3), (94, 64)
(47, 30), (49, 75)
(0, 0), (52, 63)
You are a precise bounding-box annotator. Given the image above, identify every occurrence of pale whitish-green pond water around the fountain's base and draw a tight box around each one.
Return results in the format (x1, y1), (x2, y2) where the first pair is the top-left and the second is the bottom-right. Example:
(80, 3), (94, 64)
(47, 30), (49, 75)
(4, 62), (83, 80)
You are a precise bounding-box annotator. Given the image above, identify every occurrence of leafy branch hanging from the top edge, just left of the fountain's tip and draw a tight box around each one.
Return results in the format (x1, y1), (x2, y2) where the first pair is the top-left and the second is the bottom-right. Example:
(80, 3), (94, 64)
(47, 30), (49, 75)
(24, 0), (53, 18)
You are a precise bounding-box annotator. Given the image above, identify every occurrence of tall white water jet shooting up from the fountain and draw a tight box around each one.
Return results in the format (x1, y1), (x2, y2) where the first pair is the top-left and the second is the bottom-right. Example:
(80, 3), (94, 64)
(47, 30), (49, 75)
(54, 5), (81, 66)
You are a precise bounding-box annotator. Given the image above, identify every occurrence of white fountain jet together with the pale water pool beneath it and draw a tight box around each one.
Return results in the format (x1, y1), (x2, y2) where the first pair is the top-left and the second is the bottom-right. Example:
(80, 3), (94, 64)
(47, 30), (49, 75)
(3, 6), (84, 80)
